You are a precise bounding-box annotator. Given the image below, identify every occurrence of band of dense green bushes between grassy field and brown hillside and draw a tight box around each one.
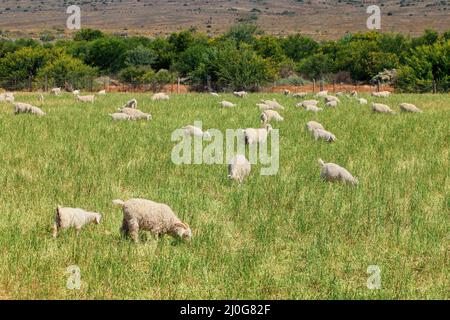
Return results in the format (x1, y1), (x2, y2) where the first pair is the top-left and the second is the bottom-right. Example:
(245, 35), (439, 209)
(0, 24), (450, 92)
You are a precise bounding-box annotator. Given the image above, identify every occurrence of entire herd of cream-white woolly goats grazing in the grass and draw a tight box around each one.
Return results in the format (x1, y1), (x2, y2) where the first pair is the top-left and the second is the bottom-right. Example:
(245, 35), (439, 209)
(0, 88), (422, 242)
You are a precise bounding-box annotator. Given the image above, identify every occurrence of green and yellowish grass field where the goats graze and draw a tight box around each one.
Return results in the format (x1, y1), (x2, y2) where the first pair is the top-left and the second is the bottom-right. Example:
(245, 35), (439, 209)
(0, 90), (450, 299)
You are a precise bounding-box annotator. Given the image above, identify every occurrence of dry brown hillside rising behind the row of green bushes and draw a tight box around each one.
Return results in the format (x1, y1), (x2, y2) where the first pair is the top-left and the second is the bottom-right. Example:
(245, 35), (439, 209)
(0, 0), (450, 39)
